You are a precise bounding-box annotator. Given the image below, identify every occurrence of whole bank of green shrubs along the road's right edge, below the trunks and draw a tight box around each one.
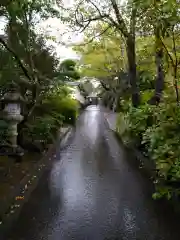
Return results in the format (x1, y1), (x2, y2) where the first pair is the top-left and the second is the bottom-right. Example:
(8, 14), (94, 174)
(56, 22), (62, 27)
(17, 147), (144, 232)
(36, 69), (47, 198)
(117, 96), (180, 199)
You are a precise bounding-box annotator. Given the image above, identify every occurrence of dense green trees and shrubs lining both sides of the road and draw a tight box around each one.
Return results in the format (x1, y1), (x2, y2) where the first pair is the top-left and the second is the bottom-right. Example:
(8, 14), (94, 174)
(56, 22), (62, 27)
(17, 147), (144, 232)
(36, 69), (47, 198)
(0, 0), (180, 198)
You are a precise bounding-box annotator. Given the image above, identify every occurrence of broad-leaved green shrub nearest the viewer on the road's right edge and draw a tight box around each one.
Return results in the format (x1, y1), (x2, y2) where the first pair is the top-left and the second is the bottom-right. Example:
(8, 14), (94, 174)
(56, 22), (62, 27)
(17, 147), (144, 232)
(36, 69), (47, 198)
(142, 104), (180, 184)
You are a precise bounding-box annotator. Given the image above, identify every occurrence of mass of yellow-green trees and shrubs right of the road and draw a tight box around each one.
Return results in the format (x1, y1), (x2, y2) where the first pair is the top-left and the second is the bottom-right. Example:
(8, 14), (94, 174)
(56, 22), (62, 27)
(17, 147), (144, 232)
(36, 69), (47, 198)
(65, 0), (180, 198)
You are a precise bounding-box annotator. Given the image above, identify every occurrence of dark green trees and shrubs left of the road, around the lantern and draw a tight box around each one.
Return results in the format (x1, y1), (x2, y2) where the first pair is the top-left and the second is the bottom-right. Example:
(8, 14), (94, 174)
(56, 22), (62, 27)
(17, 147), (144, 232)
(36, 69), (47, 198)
(0, 0), (80, 151)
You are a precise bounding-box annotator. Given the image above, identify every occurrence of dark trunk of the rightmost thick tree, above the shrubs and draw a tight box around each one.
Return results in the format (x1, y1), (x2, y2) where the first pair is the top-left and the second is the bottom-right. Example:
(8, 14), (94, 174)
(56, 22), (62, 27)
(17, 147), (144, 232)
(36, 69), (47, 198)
(148, 27), (164, 105)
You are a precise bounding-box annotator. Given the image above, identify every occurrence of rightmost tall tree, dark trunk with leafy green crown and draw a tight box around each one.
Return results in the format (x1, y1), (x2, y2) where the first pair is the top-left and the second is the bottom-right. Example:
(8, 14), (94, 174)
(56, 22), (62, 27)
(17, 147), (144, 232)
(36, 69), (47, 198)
(138, 0), (179, 104)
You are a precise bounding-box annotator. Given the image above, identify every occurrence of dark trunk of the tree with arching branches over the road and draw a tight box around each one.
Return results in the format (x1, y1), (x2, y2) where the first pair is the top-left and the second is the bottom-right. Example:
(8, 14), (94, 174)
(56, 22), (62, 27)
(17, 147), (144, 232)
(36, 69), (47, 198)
(126, 36), (140, 107)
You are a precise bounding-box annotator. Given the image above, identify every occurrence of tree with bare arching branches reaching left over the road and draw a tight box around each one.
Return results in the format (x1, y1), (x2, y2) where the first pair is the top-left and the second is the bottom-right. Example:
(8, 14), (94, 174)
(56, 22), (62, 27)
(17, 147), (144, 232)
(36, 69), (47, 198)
(64, 0), (140, 106)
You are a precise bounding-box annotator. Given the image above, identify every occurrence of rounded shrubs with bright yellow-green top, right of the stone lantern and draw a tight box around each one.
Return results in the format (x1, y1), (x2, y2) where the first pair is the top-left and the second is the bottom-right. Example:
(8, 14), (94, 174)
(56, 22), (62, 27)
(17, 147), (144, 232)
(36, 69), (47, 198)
(21, 93), (78, 151)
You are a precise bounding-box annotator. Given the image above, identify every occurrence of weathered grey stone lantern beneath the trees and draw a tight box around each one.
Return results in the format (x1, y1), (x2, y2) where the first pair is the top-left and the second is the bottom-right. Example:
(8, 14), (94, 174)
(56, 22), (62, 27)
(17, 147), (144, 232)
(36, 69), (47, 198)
(2, 83), (24, 156)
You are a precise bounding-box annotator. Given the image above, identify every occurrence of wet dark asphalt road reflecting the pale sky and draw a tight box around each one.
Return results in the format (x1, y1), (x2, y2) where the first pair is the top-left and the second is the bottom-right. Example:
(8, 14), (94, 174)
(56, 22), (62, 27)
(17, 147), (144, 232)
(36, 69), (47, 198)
(7, 106), (180, 240)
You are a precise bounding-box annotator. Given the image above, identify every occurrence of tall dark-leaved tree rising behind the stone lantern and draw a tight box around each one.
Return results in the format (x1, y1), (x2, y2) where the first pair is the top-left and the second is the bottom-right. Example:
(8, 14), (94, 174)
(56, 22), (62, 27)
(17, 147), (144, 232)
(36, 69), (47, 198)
(0, 0), (80, 149)
